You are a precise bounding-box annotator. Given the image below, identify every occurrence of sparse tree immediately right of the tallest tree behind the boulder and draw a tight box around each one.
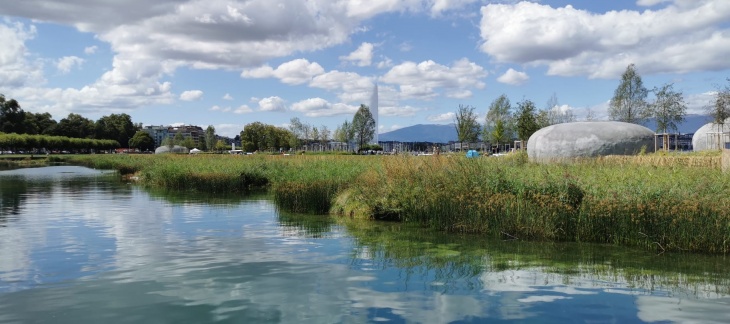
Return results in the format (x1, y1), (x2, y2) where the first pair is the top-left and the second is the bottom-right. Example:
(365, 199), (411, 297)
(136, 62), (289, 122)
(649, 83), (687, 133)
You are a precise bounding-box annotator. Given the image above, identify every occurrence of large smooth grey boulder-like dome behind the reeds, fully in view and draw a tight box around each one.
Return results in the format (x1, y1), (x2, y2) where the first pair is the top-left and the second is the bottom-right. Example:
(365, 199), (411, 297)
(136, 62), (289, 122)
(527, 121), (654, 162)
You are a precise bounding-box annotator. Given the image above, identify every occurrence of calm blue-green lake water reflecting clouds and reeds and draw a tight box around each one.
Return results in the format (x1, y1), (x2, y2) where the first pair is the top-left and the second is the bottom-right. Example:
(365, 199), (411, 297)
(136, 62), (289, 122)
(0, 166), (730, 323)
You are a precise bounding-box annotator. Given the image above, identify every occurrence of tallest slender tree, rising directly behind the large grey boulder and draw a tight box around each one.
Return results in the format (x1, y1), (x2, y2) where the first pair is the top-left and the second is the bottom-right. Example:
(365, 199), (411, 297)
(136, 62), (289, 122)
(608, 63), (650, 124)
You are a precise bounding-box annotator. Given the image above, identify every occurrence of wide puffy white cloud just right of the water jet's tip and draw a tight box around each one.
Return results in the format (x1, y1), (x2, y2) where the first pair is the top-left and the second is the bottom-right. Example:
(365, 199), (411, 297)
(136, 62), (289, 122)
(381, 58), (487, 99)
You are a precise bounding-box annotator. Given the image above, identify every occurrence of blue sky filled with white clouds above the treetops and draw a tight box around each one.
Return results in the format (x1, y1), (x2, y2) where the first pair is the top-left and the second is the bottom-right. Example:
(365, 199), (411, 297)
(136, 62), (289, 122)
(0, 0), (730, 137)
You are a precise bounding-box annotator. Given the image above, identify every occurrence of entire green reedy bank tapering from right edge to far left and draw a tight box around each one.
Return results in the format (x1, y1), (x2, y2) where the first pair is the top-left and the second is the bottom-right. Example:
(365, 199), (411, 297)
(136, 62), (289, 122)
(52, 154), (730, 254)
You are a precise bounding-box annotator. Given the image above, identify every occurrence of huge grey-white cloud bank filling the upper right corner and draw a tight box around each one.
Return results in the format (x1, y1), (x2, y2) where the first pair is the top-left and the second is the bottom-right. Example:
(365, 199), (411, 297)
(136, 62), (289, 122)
(480, 0), (730, 78)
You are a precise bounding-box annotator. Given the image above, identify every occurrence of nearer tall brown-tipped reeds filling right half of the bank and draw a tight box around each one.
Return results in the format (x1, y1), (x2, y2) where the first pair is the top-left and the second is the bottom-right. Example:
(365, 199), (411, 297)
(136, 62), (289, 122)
(335, 156), (730, 254)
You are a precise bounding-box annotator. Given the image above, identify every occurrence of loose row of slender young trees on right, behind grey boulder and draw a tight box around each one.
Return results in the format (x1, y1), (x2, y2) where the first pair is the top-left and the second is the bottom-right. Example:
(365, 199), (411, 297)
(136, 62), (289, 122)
(454, 64), (730, 153)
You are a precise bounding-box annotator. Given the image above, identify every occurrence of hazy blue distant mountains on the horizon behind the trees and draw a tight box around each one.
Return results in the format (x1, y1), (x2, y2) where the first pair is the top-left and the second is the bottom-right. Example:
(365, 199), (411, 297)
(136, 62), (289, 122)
(378, 115), (712, 143)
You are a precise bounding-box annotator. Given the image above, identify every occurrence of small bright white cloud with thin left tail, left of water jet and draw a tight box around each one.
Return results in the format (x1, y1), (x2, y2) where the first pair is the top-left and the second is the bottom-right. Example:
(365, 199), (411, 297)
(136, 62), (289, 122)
(241, 59), (324, 84)
